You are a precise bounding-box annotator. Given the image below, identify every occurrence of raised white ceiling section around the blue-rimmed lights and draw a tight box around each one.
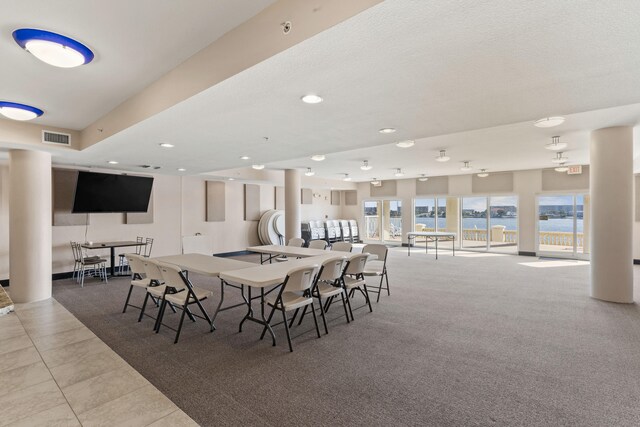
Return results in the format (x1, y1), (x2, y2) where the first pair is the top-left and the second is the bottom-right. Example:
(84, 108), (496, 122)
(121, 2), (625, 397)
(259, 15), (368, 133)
(0, 0), (275, 130)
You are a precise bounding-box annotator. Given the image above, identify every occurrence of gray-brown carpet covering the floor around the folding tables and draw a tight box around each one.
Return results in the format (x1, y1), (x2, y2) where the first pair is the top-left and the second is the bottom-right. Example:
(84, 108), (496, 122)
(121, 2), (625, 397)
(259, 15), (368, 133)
(53, 248), (640, 426)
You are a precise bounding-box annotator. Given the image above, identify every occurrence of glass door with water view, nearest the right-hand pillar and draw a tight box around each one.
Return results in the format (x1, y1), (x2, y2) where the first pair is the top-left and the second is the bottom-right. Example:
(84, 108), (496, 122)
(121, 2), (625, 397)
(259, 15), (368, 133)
(537, 194), (589, 258)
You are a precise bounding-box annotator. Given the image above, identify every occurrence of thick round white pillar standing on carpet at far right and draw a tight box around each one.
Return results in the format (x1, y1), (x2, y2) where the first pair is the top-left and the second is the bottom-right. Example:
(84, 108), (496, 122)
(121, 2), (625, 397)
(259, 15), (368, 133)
(589, 126), (633, 303)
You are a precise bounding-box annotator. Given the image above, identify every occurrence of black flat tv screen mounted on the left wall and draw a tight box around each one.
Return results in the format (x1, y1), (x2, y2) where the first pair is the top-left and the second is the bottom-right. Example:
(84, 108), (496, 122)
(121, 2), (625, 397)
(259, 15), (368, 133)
(72, 171), (153, 213)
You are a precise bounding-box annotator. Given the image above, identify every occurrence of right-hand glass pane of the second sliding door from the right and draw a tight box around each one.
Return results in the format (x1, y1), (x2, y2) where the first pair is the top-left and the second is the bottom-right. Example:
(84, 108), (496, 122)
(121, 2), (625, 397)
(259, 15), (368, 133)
(489, 196), (518, 254)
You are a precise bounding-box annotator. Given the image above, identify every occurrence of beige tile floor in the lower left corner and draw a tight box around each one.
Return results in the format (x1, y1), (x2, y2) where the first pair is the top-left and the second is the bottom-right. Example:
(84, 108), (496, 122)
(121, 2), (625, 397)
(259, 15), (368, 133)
(0, 299), (197, 426)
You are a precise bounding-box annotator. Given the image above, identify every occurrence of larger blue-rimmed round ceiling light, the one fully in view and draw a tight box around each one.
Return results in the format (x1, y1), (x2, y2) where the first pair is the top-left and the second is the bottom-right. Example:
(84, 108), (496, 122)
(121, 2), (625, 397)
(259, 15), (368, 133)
(13, 28), (94, 68)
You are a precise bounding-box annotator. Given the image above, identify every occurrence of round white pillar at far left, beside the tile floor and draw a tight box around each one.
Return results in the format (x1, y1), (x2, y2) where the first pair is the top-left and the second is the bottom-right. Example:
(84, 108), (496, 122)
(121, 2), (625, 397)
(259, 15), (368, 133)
(9, 150), (51, 302)
